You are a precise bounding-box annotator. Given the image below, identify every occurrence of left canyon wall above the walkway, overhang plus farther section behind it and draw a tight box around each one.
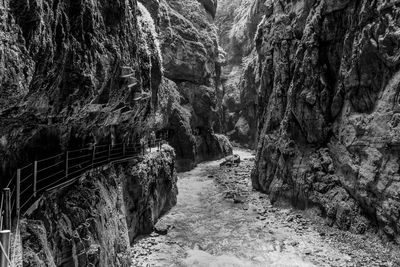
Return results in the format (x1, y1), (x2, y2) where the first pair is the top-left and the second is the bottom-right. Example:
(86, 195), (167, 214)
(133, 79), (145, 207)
(0, 0), (232, 185)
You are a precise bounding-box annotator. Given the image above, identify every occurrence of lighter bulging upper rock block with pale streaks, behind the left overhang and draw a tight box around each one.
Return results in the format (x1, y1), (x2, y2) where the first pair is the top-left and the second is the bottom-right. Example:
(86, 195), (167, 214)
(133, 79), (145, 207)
(160, 0), (218, 85)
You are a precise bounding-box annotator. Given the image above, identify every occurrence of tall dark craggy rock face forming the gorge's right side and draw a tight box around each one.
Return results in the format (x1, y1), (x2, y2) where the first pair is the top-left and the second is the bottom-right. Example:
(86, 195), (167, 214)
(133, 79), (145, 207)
(252, 0), (400, 242)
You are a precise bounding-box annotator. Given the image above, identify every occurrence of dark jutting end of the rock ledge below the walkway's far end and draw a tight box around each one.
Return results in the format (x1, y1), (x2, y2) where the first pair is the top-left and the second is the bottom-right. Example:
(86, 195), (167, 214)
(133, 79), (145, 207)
(121, 145), (178, 242)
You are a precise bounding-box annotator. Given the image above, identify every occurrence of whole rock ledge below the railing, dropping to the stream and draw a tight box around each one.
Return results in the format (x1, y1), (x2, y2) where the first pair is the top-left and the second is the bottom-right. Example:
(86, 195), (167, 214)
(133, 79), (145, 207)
(21, 146), (178, 266)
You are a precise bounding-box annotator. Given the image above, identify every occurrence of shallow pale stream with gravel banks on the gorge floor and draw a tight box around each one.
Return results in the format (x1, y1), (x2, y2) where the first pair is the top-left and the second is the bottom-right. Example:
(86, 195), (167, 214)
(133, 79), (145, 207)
(132, 150), (400, 266)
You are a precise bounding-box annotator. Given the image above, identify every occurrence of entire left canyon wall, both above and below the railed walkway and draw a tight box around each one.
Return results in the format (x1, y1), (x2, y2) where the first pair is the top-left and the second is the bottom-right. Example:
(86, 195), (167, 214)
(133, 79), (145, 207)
(0, 0), (232, 266)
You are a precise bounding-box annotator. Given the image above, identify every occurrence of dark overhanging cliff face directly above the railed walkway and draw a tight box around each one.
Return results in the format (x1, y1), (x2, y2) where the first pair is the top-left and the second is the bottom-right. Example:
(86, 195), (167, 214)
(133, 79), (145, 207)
(0, 0), (162, 184)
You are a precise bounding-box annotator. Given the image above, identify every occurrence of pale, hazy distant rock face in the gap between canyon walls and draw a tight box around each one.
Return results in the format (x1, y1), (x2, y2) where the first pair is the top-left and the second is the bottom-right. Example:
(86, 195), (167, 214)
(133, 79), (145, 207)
(216, 0), (265, 147)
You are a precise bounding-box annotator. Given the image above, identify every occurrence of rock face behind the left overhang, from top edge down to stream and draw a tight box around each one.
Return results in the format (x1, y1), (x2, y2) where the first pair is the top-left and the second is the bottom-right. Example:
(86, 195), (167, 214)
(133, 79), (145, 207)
(143, 0), (232, 171)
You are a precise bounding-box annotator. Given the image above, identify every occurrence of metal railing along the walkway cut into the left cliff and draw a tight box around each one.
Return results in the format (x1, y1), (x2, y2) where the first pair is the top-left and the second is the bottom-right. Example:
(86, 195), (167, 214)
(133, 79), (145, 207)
(0, 139), (164, 267)
